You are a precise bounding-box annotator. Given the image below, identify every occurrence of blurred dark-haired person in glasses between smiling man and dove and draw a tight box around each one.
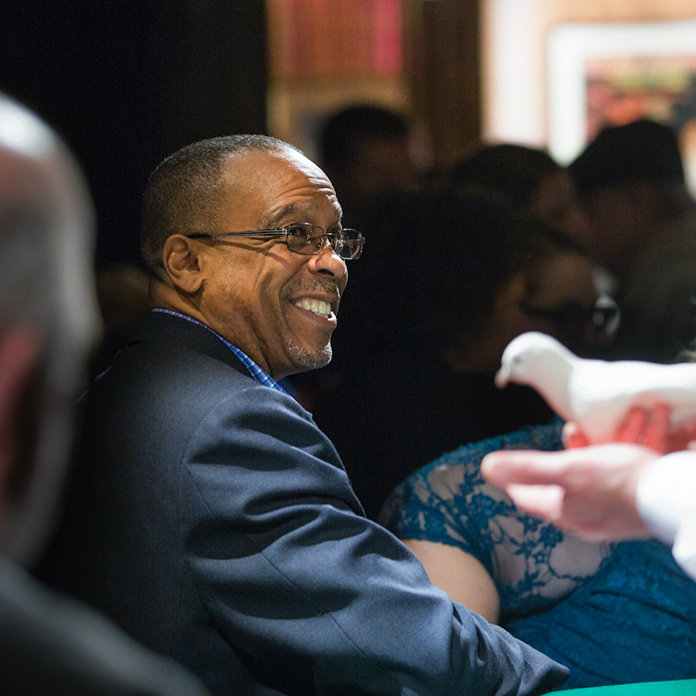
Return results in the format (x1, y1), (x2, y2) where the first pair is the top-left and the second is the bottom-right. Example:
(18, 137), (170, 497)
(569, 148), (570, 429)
(313, 185), (607, 519)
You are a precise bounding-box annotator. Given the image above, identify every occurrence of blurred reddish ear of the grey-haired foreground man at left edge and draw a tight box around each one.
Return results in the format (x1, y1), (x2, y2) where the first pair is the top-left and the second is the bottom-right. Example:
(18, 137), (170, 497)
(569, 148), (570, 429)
(0, 325), (42, 508)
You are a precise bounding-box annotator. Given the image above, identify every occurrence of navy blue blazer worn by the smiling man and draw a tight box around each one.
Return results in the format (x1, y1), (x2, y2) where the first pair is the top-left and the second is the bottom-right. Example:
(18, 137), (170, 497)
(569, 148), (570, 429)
(38, 313), (567, 696)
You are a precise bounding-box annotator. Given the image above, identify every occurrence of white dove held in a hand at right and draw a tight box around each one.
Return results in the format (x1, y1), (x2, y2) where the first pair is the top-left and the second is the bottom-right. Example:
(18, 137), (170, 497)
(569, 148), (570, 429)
(495, 331), (696, 444)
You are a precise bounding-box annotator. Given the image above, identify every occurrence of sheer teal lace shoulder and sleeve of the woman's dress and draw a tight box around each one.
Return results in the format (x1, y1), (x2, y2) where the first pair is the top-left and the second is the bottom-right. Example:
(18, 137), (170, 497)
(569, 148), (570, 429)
(381, 420), (613, 620)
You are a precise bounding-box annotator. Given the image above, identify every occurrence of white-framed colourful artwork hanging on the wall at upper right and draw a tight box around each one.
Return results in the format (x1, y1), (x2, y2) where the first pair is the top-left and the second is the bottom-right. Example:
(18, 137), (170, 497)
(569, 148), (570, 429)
(547, 20), (696, 191)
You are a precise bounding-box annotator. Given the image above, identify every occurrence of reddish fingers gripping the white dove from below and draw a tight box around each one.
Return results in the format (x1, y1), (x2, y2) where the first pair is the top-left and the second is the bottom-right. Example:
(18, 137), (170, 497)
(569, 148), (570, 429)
(563, 404), (696, 454)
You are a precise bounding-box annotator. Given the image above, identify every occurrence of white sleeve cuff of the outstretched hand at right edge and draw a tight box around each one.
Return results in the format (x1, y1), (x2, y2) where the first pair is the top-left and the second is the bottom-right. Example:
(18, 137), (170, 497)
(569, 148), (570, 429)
(636, 450), (696, 580)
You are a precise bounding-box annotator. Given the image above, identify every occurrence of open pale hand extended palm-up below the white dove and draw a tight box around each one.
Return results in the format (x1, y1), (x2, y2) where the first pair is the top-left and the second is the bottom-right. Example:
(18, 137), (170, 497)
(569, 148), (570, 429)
(481, 443), (659, 541)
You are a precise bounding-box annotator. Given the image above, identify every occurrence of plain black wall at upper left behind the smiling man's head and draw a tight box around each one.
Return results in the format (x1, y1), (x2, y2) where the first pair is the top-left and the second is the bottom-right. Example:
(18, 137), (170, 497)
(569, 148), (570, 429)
(0, 0), (267, 266)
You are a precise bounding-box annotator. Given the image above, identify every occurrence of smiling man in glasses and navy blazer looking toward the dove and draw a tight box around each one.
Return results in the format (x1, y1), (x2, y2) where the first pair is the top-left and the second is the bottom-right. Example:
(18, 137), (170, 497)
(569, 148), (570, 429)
(41, 136), (566, 696)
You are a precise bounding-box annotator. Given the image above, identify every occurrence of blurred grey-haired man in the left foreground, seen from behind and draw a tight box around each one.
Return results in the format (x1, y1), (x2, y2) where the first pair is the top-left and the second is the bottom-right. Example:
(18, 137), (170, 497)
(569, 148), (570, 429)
(0, 95), (206, 696)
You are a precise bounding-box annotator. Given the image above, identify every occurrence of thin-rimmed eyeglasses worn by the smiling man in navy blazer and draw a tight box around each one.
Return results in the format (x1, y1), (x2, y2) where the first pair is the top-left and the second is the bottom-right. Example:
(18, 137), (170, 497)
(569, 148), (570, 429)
(188, 222), (365, 261)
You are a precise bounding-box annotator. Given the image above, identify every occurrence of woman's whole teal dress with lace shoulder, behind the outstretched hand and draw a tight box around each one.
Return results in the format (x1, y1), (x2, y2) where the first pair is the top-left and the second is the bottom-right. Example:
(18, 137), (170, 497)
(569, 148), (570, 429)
(380, 421), (696, 688)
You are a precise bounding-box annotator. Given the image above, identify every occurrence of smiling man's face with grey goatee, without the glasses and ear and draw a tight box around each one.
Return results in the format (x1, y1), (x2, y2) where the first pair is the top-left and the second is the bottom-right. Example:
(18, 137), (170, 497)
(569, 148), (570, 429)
(200, 149), (347, 379)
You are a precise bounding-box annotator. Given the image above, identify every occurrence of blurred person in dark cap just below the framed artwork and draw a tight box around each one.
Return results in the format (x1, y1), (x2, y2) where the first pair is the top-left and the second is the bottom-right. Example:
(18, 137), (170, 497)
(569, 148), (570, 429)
(570, 119), (696, 362)
